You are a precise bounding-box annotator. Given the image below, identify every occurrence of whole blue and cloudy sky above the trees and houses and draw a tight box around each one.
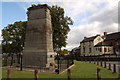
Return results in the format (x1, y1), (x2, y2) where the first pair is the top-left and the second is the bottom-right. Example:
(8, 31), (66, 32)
(0, 0), (119, 50)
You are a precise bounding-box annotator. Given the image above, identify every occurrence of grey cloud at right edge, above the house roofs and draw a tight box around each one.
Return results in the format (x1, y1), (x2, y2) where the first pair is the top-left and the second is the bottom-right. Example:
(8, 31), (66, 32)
(89, 6), (118, 26)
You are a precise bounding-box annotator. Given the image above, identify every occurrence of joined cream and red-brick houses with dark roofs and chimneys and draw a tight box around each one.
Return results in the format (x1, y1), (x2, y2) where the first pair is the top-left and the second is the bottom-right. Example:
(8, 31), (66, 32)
(80, 32), (120, 56)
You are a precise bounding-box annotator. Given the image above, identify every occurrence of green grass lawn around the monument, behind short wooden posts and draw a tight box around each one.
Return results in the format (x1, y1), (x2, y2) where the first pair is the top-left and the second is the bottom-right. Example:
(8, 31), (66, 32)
(2, 61), (118, 78)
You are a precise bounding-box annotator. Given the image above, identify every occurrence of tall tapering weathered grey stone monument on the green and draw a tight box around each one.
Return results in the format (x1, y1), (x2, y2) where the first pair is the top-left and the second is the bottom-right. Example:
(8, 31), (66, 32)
(23, 5), (54, 68)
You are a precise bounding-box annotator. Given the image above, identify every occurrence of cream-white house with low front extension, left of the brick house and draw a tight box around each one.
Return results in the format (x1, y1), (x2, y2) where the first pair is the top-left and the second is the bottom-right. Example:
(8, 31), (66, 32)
(80, 33), (113, 56)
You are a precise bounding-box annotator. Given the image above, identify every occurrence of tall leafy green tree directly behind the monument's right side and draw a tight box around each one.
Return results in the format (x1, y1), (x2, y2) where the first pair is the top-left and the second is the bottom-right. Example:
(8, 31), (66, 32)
(50, 6), (73, 50)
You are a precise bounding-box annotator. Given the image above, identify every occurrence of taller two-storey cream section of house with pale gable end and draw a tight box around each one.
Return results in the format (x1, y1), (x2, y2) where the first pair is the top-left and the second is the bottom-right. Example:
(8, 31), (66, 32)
(80, 35), (103, 56)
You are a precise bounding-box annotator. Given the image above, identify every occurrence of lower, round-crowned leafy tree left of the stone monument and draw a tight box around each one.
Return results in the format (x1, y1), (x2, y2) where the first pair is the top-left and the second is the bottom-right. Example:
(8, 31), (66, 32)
(2, 21), (27, 65)
